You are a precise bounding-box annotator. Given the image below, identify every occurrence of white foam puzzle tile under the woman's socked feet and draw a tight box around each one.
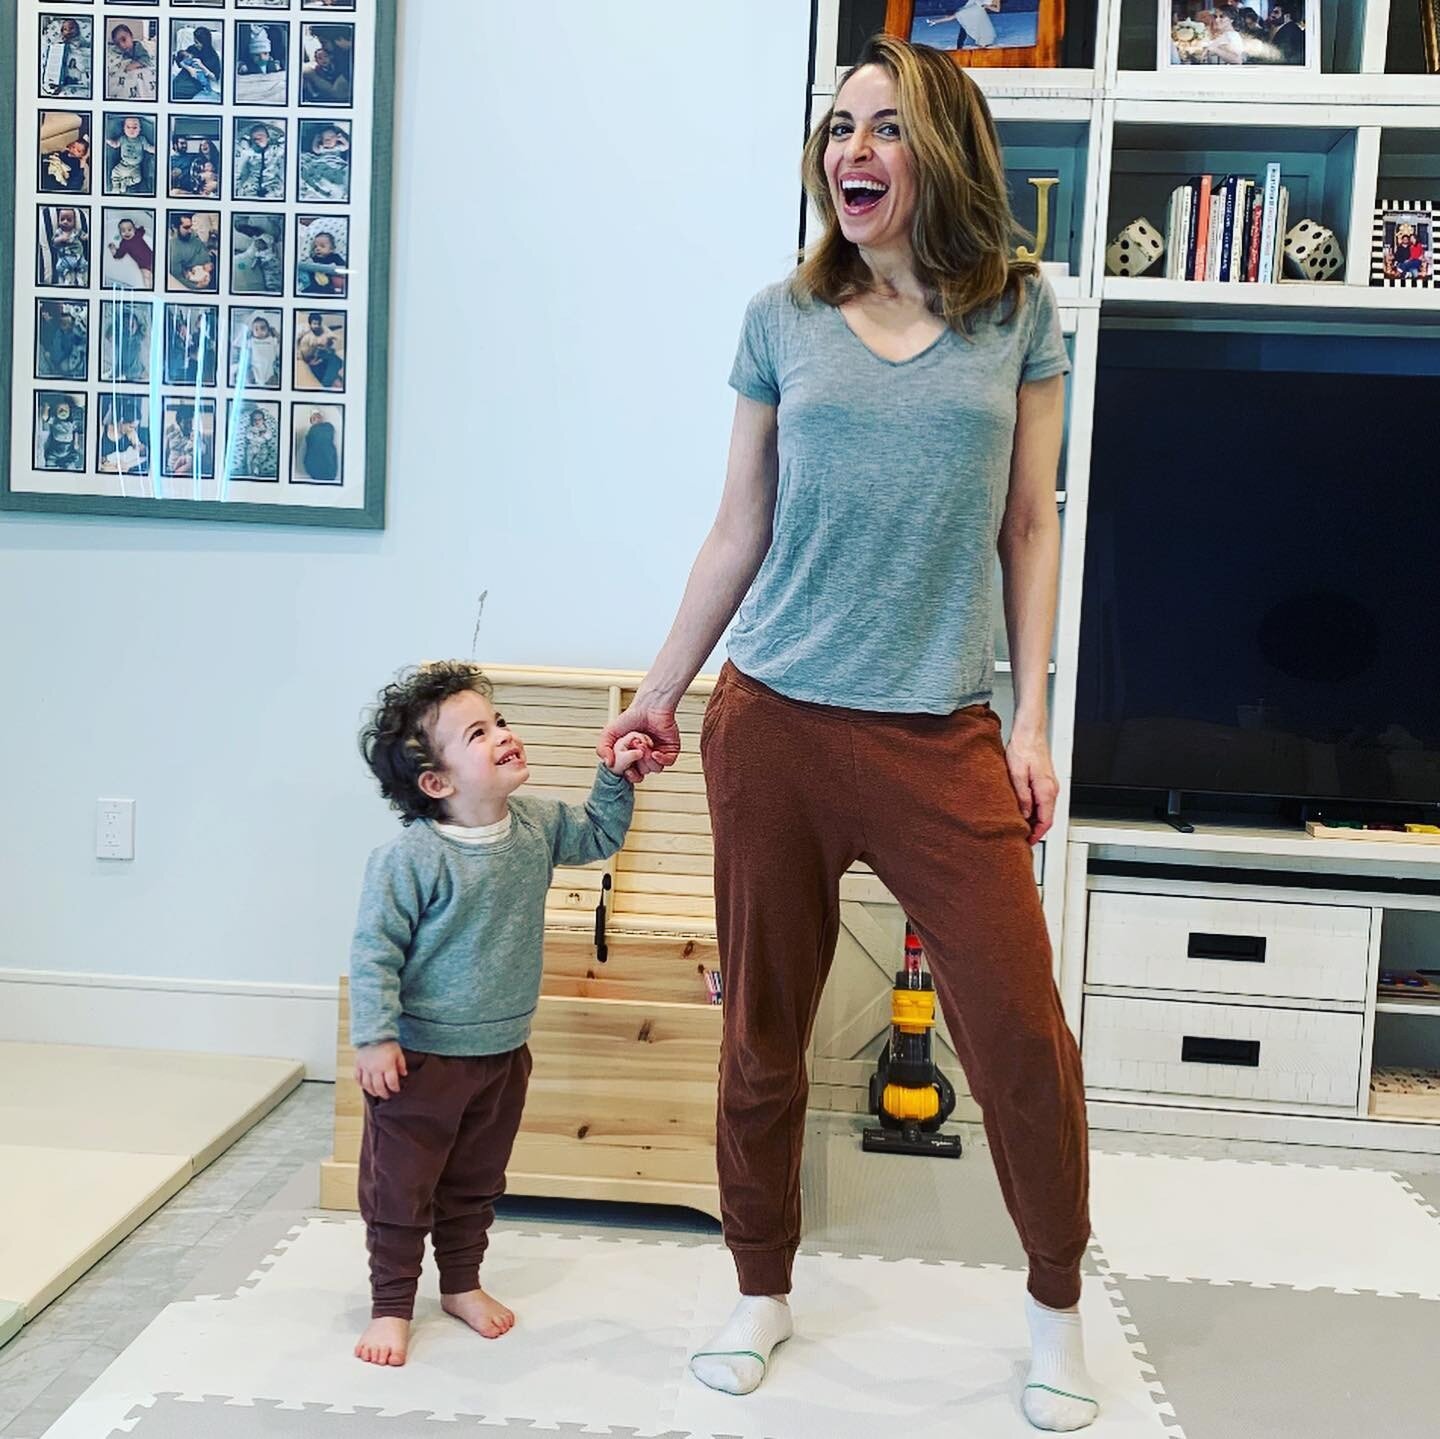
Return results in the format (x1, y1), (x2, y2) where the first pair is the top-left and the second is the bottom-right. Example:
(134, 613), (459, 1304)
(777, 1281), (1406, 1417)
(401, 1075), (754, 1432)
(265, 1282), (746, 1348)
(674, 1250), (1176, 1439)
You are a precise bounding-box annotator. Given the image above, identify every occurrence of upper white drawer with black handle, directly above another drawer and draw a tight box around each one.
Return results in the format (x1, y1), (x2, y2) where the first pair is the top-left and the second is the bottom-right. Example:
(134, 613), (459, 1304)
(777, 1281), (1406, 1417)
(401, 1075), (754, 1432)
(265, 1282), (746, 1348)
(1086, 890), (1369, 1001)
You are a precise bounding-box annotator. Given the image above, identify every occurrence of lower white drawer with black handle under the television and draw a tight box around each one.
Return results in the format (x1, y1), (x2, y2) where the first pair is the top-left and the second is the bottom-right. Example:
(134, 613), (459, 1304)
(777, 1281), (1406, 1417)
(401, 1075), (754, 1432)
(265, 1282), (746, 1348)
(1084, 995), (1364, 1111)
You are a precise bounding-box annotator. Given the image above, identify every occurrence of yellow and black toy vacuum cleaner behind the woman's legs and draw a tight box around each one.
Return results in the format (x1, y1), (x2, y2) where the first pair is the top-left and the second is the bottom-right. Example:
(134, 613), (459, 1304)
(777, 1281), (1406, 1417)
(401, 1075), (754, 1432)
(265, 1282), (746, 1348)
(863, 920), (960, 1160)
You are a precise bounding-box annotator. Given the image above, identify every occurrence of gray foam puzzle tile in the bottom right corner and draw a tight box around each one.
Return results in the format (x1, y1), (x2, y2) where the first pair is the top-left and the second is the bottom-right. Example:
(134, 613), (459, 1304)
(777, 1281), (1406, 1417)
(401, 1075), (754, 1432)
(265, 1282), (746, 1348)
(1117, 1279), (1440, 1439)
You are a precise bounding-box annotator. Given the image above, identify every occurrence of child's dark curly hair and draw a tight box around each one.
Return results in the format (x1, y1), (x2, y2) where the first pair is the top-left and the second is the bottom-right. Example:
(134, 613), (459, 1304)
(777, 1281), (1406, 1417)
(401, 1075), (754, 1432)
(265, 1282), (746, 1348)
(360, 660), (495, 824)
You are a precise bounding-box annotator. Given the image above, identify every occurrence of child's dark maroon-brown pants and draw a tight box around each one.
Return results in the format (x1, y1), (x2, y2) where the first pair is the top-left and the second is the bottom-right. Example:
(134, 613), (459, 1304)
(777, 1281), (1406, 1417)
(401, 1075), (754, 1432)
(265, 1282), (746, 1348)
(360, 1046), (530, 1319)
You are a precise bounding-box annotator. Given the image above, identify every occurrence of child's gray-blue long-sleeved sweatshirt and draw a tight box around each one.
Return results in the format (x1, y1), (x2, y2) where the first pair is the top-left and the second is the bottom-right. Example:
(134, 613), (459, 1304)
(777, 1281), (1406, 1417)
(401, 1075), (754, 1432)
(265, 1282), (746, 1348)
(350, 765), (635, 1054)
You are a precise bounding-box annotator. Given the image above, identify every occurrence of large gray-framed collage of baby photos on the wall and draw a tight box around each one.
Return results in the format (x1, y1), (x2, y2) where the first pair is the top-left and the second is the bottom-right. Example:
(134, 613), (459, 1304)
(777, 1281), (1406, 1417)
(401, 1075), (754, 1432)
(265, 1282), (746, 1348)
(0, 0), (394, 529)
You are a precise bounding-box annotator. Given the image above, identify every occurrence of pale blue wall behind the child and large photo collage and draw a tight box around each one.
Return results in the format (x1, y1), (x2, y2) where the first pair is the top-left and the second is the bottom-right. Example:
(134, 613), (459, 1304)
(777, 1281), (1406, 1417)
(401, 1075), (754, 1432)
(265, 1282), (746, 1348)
(0, 0), (809, 982)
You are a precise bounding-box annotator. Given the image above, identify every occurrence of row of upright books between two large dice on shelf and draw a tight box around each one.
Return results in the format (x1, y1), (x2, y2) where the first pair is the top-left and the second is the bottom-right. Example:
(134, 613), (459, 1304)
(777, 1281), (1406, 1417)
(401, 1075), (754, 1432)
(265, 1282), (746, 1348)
(1165, 164), (1290, 285)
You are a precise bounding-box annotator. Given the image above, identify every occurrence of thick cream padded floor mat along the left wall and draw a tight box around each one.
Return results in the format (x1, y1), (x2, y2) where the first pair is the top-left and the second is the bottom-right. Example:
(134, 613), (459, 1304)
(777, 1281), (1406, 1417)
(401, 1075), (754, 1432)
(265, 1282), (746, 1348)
(0, 1044), (302, 1344)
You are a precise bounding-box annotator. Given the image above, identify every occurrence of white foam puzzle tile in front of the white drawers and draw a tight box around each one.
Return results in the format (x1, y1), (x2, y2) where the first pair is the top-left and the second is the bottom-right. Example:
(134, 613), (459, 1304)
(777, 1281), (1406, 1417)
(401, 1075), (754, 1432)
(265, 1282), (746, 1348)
(1090, 1154), (1440, 1299)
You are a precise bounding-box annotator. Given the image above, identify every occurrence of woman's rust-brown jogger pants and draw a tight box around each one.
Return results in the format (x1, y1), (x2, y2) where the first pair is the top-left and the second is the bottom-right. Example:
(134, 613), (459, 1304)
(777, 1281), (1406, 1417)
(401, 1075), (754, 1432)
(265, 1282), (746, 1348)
(700, 664), (1090, 1308)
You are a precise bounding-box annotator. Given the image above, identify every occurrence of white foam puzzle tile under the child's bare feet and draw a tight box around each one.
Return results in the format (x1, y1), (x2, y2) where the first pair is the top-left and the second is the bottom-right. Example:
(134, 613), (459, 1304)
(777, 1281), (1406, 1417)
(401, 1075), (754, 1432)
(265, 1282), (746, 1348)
(40, 1221), (697, 1439)
